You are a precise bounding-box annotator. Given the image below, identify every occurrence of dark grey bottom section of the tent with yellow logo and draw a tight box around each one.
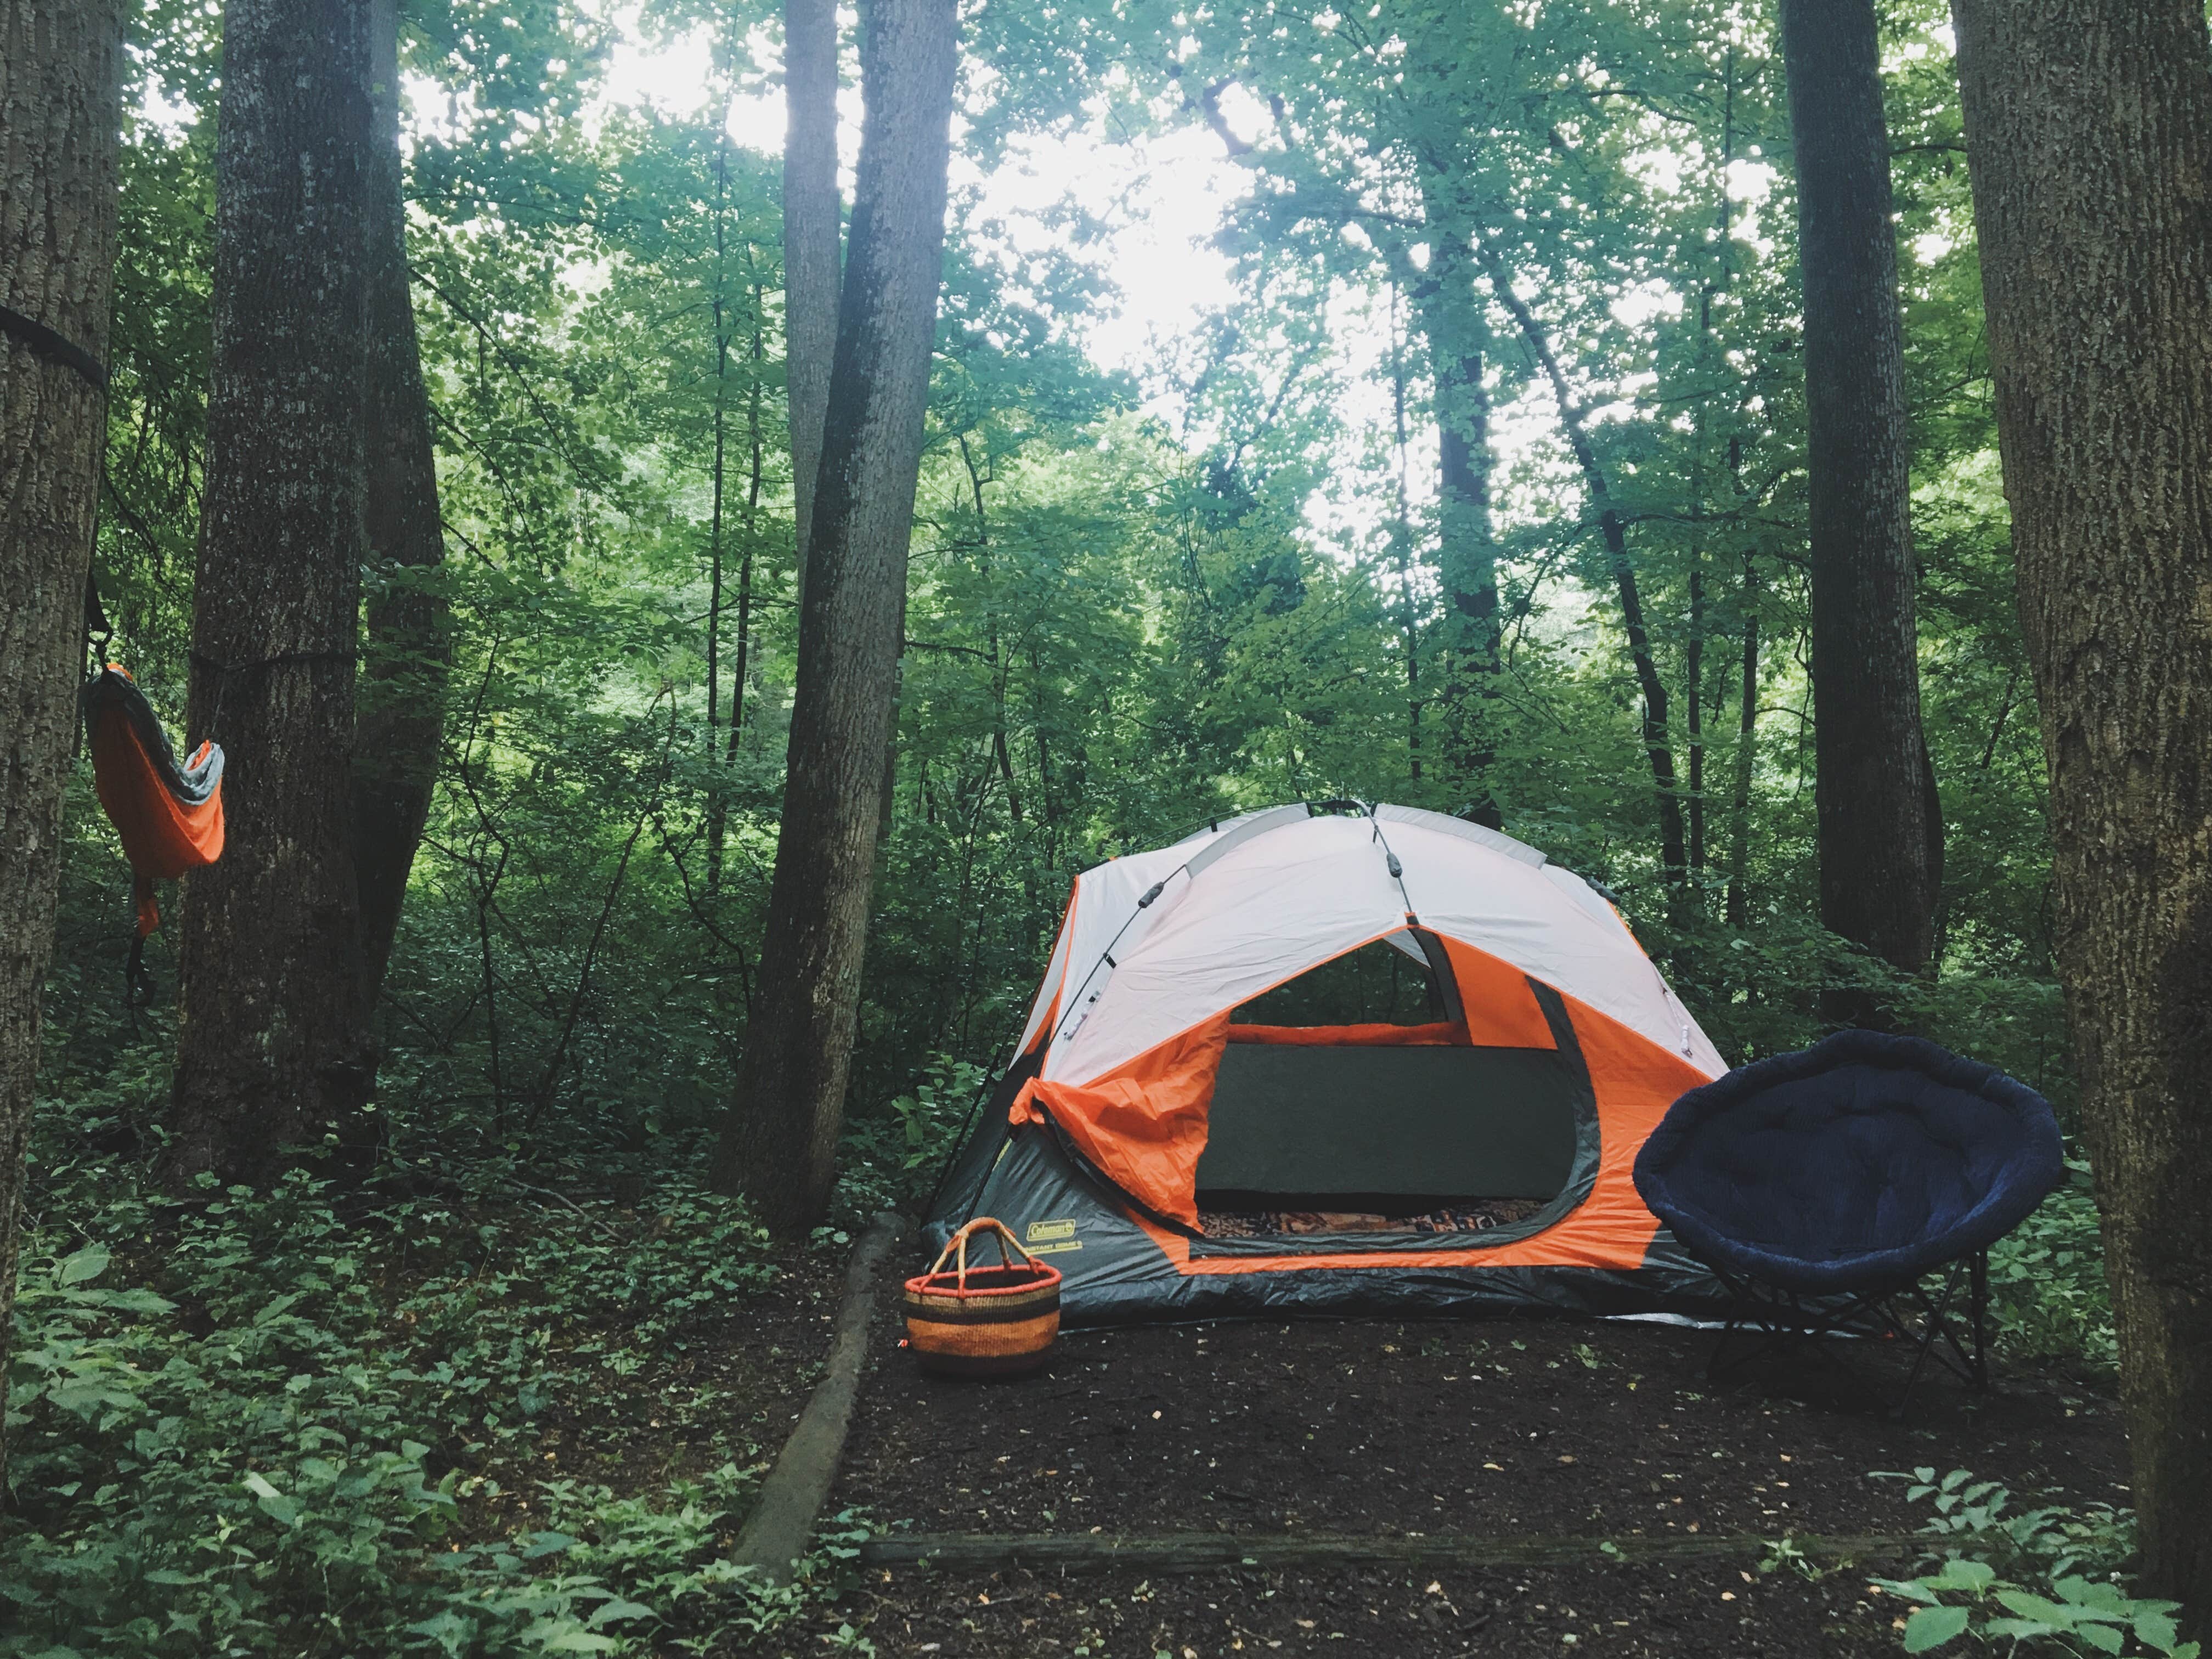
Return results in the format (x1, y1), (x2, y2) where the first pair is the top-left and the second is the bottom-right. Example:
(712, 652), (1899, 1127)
(922, 1124), (1730, 1329)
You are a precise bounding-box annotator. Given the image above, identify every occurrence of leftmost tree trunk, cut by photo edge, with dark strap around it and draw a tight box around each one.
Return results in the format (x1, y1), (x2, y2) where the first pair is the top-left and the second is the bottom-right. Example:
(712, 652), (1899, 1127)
(0, 0), (124, 1491)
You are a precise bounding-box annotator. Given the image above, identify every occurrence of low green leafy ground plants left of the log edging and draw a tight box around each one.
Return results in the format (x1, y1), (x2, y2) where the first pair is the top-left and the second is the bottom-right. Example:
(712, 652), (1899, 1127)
(0, 1164), (851, 1659)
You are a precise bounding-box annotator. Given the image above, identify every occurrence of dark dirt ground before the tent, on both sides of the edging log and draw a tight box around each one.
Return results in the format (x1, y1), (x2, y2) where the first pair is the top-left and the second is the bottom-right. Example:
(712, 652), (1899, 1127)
(756, 1265), (2128, 1659)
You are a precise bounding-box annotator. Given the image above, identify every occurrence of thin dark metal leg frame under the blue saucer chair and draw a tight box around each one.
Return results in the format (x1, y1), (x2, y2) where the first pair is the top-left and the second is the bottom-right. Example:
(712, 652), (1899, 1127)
(1706, 1250), (1989, 1411)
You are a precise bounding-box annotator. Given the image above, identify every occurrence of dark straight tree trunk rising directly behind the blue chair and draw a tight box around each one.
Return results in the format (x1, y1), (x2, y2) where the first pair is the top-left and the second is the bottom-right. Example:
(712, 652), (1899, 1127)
(1783, 0), (1936, 1000)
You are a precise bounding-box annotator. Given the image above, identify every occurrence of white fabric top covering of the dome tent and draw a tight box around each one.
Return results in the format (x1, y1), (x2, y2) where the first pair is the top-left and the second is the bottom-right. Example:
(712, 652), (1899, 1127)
(1024, 808), (1728, 1084)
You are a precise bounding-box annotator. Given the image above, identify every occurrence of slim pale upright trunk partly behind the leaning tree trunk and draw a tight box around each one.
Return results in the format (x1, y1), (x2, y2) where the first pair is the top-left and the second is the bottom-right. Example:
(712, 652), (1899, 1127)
(783, 0), (838, 593)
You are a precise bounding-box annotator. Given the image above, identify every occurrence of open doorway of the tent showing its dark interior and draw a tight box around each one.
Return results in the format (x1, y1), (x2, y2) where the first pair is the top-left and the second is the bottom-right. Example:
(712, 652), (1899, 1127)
(1197, 936), (1586, 1237)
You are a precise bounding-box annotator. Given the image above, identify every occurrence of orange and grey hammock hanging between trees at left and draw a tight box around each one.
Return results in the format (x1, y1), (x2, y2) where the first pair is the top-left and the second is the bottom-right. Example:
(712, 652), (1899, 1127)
(84, 664), (223, 946)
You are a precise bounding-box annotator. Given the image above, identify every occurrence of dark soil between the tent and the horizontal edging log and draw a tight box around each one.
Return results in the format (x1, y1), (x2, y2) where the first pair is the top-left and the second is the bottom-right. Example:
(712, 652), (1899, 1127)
(832, 1265), (2128, 1537)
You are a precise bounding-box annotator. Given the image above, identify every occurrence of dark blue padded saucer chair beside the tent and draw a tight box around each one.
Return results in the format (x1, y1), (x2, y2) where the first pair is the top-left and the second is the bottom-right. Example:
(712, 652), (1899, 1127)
(1637, 1031), (2066, 1409)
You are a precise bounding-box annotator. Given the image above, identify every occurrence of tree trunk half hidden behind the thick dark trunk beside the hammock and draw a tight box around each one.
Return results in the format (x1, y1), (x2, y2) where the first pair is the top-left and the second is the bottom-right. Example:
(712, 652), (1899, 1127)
(354, 0), (454, 1009)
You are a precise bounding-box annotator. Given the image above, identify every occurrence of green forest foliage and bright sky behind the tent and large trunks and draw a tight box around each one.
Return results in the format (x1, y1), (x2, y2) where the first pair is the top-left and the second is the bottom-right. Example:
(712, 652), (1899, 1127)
(47, 2), (2066, 1168)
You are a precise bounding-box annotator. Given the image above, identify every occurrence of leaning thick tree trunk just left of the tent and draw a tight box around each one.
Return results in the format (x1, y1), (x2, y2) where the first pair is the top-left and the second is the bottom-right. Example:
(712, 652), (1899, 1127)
(716, 0), (958, 1230)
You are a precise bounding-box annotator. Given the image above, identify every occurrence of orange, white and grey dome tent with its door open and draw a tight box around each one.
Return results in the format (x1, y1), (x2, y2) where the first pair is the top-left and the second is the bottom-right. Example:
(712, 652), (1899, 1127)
(929, 803), (1725, 1325)
